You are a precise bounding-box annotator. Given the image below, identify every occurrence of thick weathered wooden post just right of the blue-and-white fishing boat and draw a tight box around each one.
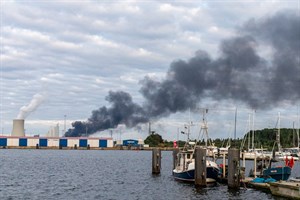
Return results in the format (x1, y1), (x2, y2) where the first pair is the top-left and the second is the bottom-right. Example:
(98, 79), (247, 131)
(228, 148), (240, 189)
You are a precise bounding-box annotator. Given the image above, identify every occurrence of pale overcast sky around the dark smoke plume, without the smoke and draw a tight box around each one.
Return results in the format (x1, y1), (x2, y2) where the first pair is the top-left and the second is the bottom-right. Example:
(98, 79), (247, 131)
(0, 0), (300, 140)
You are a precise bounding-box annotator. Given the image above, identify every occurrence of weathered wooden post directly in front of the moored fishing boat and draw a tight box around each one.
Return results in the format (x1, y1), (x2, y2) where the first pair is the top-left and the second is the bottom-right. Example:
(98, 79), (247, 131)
(195, 148), (206, 187)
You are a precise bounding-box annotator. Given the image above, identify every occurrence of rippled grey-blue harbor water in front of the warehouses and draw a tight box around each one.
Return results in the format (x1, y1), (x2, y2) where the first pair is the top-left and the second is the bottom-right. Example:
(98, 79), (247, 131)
(0, 149), (300, 200)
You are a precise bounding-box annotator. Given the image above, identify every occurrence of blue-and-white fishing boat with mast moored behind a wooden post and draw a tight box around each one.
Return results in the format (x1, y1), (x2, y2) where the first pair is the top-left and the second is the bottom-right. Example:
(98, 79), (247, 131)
(173, 111), (220, 182)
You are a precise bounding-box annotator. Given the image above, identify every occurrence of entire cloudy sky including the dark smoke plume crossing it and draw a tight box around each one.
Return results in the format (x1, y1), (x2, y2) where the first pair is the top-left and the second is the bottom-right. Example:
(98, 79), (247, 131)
(0, 0), (300, 143)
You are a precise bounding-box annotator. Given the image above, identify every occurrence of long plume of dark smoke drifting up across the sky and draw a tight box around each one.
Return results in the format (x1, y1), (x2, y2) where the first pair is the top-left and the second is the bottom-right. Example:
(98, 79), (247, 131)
(66, 12), (300, 136)
